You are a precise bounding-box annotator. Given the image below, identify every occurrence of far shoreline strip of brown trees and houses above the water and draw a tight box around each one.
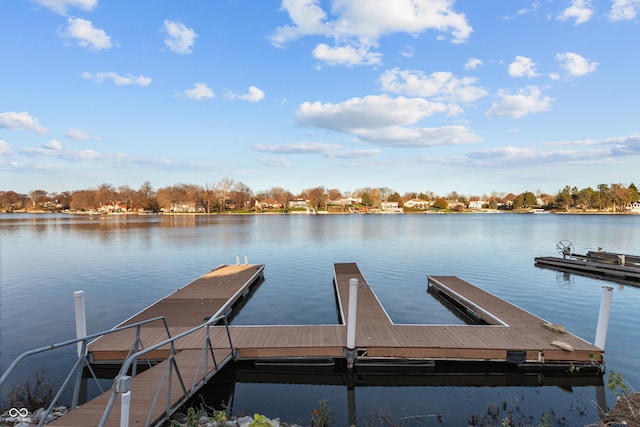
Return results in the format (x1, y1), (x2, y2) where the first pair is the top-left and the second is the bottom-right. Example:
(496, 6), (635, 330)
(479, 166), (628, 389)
(0, 181), (640, 215)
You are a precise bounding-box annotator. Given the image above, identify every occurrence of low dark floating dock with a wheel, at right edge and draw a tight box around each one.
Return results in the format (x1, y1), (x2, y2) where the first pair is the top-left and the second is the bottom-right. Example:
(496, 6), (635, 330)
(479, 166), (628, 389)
(535, 251), (640, 286)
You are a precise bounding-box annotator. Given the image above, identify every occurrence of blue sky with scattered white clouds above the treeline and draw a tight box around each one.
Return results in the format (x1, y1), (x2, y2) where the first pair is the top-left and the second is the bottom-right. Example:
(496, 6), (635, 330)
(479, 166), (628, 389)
(0, 0), (640, 196)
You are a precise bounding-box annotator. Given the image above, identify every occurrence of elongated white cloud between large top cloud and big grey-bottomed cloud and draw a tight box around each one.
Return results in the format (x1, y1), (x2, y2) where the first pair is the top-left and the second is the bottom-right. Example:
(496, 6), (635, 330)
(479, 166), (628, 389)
(379, 68), (487, 102)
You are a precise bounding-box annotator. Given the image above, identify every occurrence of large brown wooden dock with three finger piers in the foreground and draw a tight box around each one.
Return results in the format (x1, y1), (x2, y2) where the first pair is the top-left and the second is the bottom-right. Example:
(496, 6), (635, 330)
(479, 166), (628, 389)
(51, 263), (604, 426)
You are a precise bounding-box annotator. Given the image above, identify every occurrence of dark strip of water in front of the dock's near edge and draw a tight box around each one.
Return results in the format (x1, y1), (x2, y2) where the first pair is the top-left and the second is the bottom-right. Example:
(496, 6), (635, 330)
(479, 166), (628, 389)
(199, 363), (607, 426)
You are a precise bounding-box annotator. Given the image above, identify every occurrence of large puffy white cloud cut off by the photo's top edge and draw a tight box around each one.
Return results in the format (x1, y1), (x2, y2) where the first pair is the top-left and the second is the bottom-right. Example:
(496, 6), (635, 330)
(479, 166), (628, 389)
(270, 0), (473, 65)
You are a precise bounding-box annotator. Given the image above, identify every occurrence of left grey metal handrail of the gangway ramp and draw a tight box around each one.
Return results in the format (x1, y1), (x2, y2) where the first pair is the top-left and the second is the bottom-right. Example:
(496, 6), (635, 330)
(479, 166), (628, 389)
(0, 316), (171, 427)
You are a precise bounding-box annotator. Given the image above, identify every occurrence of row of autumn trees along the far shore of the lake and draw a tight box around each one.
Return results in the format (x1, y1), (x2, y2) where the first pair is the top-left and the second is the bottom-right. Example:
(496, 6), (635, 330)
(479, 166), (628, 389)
(0, 177), (640, 213)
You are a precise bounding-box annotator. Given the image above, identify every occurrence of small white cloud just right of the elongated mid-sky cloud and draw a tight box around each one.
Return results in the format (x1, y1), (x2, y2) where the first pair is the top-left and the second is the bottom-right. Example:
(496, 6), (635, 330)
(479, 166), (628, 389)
(485, 86), (553, 119)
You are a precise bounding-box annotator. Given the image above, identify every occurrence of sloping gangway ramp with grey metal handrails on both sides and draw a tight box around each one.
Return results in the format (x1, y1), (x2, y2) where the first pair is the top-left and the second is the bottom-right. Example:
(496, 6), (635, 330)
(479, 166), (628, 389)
(0, 315), (236, 427)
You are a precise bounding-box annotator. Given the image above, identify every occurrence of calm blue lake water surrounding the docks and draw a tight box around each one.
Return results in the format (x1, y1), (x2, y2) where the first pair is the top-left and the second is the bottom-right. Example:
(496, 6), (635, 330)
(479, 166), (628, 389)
(0, 214), (640, 425)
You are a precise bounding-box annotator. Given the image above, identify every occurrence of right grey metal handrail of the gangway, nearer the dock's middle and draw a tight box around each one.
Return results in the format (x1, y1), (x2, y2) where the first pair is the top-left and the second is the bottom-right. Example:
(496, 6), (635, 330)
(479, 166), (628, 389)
(98, 315), (235, 427)
